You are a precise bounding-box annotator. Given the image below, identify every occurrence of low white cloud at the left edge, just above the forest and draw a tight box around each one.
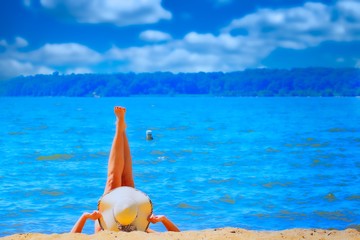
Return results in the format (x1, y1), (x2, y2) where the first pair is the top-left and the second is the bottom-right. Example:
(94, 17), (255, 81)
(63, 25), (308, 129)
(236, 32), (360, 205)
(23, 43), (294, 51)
(0, 37), (103, 79)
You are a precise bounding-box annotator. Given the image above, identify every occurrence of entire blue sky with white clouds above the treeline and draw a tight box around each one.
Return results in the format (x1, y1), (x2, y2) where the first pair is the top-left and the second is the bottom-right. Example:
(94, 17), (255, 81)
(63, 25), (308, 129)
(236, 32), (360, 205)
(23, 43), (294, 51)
(0, 0), (360, 79)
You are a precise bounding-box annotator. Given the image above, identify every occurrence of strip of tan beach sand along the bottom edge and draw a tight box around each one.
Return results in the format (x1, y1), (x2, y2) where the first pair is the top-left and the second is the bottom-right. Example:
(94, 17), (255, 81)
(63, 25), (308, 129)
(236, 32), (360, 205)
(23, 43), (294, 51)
(0, 228), (360, 240)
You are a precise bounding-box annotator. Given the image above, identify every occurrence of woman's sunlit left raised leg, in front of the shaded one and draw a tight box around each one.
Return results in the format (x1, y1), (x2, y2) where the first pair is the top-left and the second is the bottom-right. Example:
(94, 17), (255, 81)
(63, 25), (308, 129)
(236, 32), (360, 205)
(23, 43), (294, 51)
(104, 107), (130, 194)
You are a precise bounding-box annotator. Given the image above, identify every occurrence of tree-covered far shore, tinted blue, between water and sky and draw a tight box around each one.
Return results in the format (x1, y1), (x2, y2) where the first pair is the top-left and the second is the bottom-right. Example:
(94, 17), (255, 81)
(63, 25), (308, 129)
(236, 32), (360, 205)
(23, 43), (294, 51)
(0, 68), (360, 97)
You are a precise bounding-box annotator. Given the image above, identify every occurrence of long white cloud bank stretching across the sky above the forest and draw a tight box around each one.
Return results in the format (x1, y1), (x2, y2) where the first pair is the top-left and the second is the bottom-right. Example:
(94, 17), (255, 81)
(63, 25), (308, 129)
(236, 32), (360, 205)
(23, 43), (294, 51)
(0, 0), (360, 78)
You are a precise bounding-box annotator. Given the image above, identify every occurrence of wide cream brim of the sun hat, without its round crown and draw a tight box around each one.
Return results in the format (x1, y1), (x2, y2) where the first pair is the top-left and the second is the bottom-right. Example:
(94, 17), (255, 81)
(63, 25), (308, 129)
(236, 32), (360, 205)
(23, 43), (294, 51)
(98, 187), (153, 231)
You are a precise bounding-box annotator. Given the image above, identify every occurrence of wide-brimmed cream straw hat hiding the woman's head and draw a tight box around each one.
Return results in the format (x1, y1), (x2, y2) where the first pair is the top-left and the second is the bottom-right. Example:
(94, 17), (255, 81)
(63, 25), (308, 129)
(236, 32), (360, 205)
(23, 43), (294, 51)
(98, 187), (153, 232)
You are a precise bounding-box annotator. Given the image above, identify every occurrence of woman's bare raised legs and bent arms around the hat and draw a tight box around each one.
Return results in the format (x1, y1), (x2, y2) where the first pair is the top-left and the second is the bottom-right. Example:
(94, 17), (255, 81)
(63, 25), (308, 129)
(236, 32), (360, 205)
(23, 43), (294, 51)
(71, 107), (180, 233)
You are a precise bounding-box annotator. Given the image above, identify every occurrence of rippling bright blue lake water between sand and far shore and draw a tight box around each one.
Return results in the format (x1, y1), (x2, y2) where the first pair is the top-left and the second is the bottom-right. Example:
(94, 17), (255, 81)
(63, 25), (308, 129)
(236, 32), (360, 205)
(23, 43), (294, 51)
(0, 97), (360, 236)
